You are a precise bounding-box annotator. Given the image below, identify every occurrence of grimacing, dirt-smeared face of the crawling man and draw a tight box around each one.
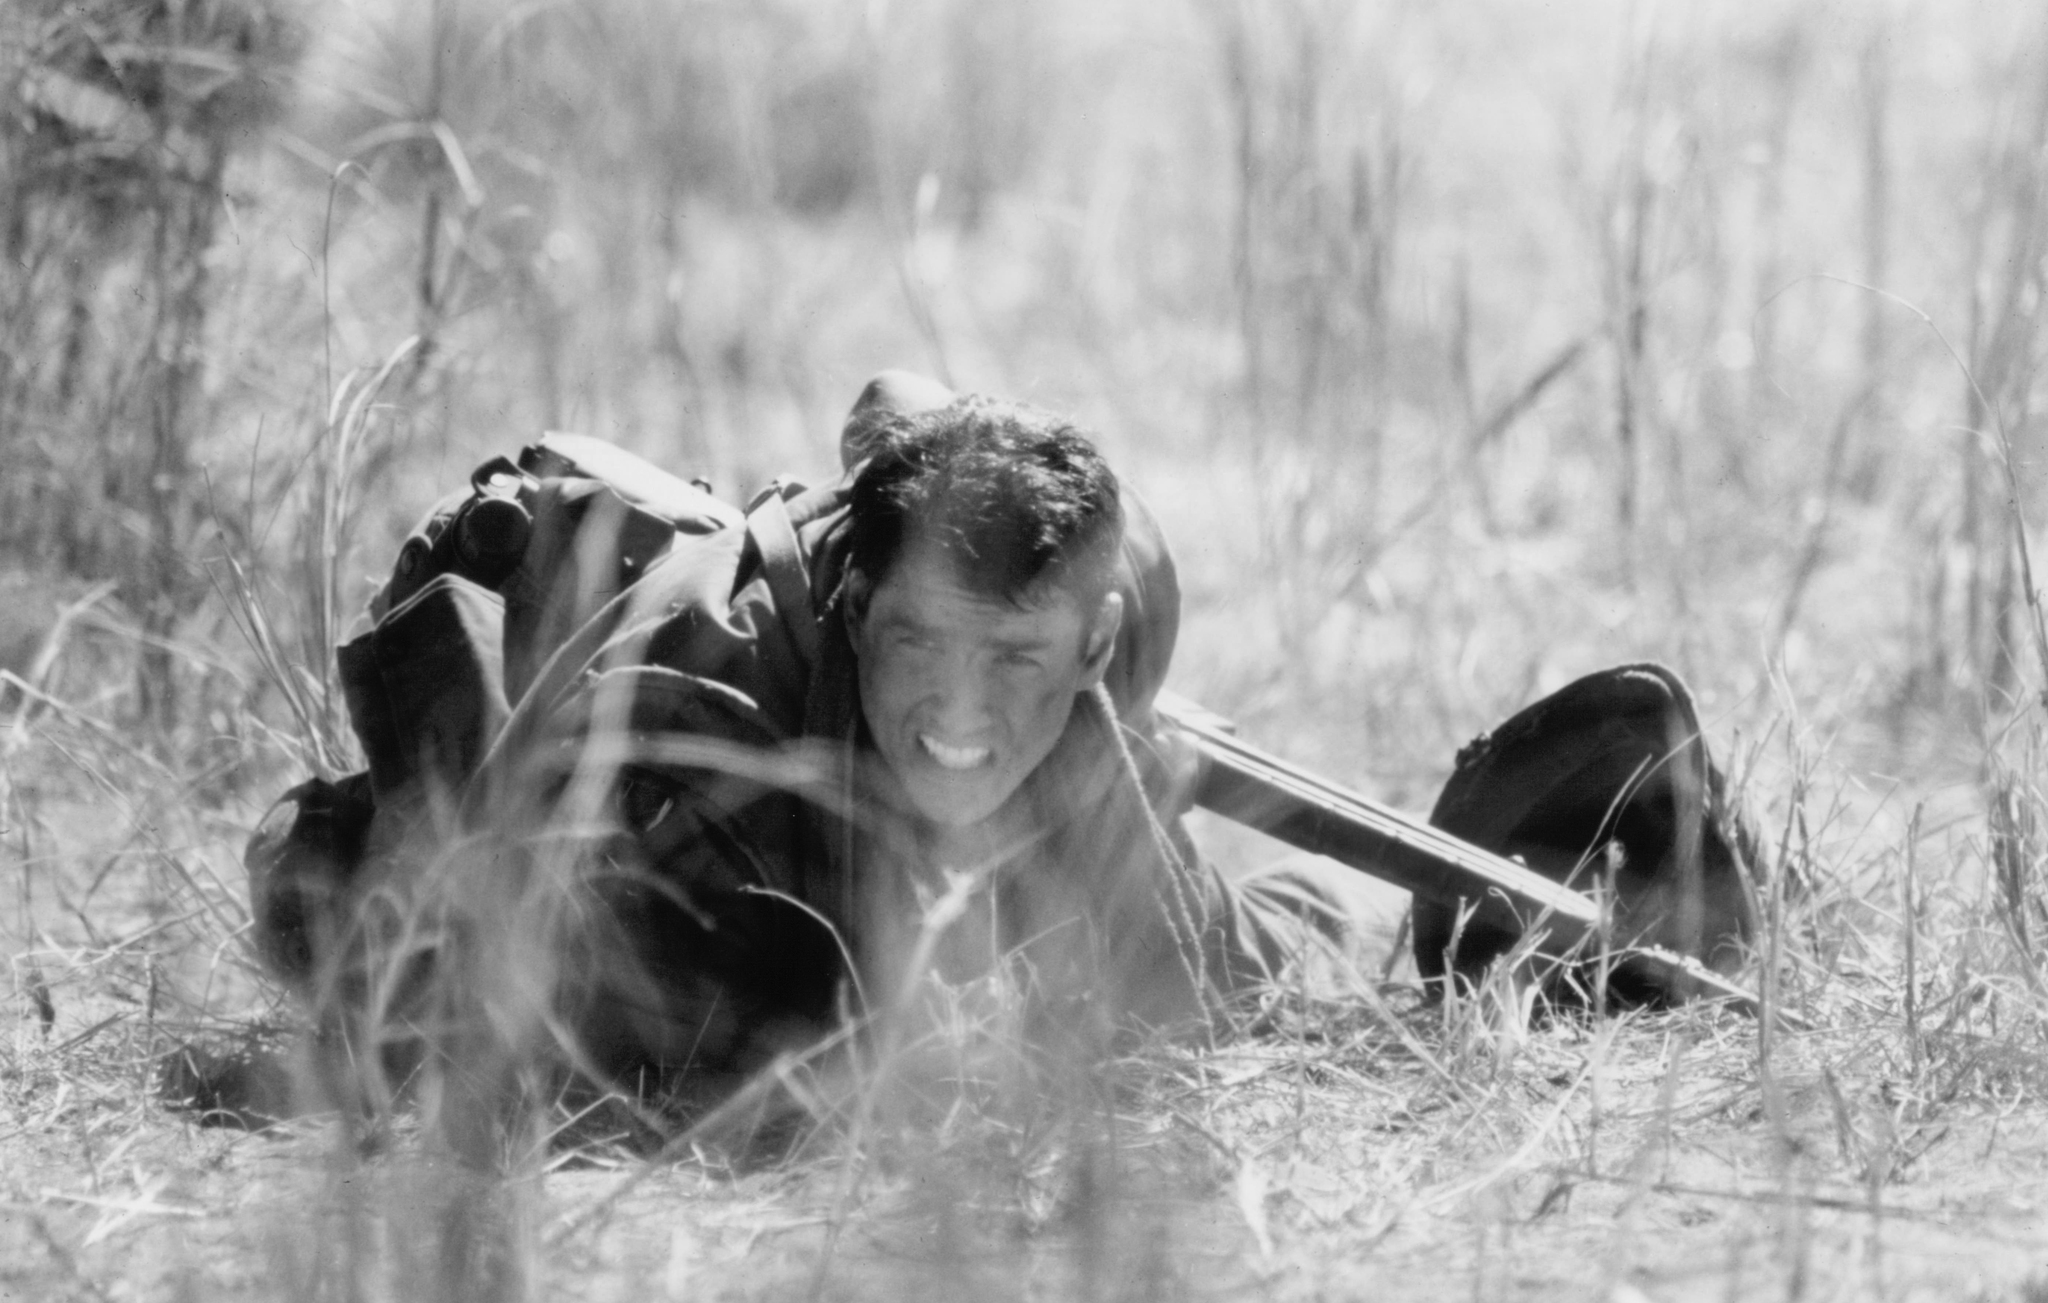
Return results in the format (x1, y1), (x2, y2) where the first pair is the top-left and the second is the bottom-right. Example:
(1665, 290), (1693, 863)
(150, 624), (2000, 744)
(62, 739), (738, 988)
(850, 541), (1122, 828)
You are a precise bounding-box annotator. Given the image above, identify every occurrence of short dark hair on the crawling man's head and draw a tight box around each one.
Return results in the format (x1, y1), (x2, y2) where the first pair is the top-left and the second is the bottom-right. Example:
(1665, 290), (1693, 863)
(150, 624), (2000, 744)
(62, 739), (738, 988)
(848, 395), (1124, 606)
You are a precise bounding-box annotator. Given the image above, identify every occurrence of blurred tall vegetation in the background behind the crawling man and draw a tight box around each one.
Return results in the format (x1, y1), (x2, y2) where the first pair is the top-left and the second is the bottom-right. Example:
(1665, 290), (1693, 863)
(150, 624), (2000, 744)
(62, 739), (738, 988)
(0, 0), (2048, 917)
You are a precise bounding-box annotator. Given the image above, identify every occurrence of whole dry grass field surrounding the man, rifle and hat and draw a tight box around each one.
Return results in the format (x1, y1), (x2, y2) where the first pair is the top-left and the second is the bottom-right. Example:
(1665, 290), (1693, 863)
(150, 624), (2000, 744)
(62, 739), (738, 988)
(12, 0), (2048, 1301)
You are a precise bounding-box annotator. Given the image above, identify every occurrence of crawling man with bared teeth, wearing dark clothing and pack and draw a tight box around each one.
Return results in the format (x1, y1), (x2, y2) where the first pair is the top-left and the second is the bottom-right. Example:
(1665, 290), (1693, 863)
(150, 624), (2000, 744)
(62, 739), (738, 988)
(250, 377), (1327, 1114)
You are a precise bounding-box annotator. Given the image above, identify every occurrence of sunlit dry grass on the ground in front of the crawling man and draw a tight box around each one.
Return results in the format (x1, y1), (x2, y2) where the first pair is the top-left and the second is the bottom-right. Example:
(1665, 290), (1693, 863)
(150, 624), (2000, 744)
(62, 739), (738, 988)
(12, 676), (2048, 1299)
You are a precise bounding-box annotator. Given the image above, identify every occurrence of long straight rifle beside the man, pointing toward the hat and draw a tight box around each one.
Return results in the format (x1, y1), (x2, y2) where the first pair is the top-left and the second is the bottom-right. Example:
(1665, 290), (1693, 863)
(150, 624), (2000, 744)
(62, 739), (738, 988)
(1155, 692), (1804, 1028)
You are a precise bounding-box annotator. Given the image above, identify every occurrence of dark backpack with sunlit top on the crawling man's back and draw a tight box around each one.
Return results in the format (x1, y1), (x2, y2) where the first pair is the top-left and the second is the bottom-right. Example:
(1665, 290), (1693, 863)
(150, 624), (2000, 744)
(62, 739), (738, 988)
(244, 434), (743, 996)
